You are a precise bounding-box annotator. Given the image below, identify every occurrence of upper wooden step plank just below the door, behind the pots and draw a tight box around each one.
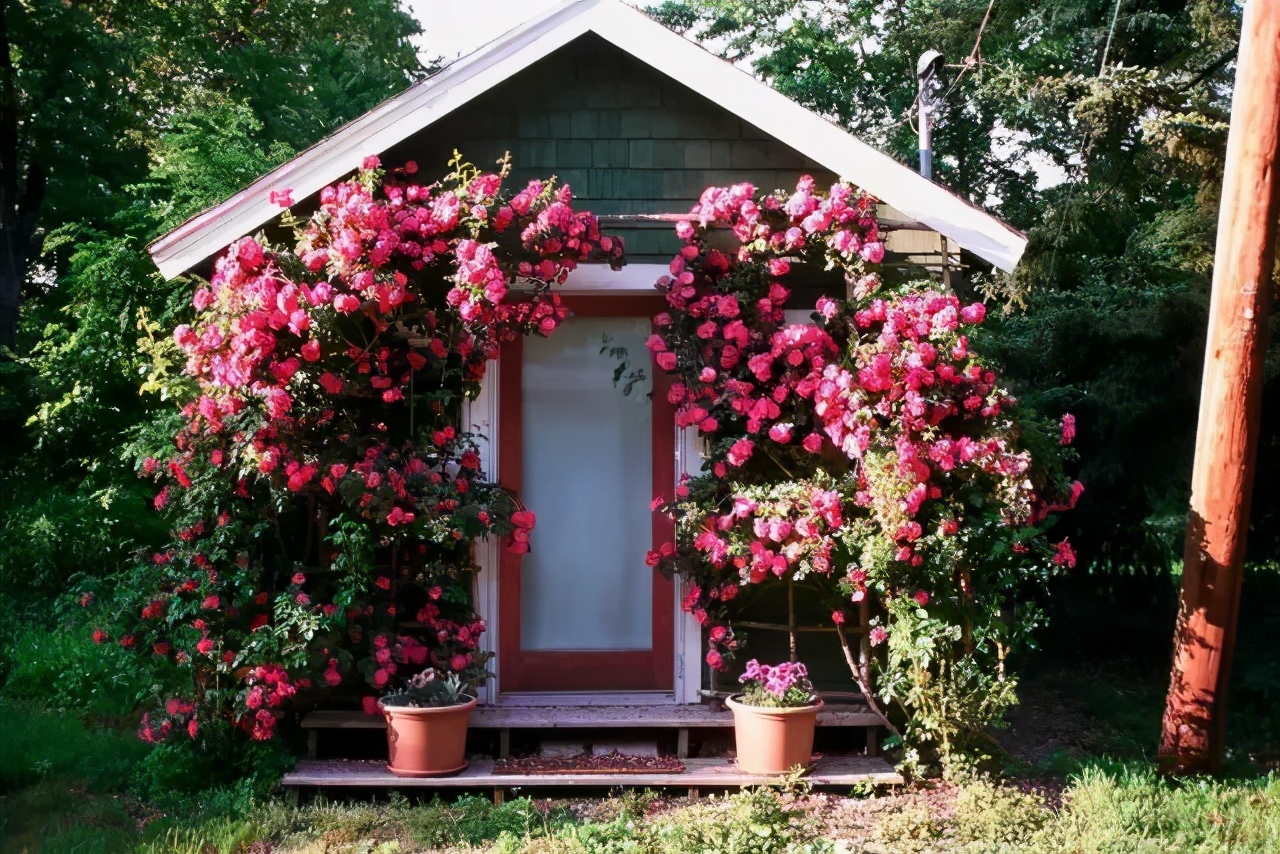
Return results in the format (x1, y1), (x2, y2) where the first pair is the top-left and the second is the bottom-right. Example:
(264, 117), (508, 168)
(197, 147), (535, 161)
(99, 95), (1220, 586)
(302, 704), (883, 730)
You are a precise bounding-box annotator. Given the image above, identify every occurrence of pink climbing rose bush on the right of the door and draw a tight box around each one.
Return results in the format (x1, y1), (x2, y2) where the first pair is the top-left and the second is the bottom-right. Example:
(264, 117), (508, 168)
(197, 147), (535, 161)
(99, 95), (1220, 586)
(649, 177), (1083, 778)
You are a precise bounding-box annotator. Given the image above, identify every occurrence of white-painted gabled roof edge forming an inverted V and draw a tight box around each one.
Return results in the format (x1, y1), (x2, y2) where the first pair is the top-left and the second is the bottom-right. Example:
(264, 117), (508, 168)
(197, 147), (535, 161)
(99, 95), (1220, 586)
(150, 0), (1027, 277)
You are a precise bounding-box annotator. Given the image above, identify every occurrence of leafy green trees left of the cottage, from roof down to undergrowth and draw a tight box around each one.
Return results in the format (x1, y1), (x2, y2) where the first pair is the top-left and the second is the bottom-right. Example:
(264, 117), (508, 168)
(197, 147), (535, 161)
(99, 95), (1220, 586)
(0, 0), (421, 615)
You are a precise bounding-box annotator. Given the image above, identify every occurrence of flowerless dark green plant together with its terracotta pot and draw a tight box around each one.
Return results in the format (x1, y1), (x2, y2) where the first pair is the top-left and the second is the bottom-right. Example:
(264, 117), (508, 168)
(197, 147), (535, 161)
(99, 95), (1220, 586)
(378, 667), (476, 777)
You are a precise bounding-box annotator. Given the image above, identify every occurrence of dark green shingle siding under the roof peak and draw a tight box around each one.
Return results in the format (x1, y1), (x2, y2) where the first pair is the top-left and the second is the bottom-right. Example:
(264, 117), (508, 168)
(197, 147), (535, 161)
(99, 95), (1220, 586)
(384, 35), (836, 264)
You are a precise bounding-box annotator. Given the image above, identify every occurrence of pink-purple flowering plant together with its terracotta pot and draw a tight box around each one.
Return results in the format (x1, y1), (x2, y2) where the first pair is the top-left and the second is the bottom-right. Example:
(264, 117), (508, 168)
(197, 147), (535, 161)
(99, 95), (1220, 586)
(724, 658), (823, 775)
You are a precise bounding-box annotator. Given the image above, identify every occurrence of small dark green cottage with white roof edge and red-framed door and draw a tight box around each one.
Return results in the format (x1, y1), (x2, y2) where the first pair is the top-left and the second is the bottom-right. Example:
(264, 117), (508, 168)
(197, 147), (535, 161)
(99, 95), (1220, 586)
(151, 0), (1025, 707)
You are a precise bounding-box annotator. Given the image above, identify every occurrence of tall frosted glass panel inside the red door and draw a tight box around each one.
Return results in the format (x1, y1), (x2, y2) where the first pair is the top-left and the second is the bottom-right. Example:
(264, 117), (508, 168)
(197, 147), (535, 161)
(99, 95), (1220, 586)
(520, 318), (653, 650)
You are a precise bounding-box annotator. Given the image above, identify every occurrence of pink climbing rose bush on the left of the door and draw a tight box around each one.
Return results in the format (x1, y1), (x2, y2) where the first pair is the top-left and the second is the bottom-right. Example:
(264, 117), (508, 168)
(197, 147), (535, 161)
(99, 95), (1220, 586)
(103, 157), (622, 740)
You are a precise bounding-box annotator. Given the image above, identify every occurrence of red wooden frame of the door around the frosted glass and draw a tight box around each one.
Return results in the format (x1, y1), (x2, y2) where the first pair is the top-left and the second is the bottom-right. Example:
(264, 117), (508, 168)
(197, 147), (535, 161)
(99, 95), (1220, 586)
(498, 296), (676, 693)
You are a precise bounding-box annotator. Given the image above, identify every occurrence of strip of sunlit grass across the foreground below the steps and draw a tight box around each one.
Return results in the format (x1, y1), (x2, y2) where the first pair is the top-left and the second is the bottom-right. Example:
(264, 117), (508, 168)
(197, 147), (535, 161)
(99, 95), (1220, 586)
(0, 742), (1280, 854)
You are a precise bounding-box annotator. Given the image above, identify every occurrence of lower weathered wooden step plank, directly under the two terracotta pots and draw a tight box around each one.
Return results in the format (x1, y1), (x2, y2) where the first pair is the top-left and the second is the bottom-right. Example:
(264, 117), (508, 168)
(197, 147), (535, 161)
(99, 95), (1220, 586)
(284, 757), (902, 790)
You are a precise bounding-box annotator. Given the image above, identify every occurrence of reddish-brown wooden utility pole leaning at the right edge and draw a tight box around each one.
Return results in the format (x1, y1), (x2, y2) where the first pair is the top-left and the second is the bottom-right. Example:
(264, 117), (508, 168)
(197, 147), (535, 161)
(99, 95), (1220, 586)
(1160, 0), (1280, 773)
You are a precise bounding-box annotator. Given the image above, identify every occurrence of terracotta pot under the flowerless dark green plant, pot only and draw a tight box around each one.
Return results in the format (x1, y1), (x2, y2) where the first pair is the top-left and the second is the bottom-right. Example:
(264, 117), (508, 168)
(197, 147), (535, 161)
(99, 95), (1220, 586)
(378, 697), (476, 777)
